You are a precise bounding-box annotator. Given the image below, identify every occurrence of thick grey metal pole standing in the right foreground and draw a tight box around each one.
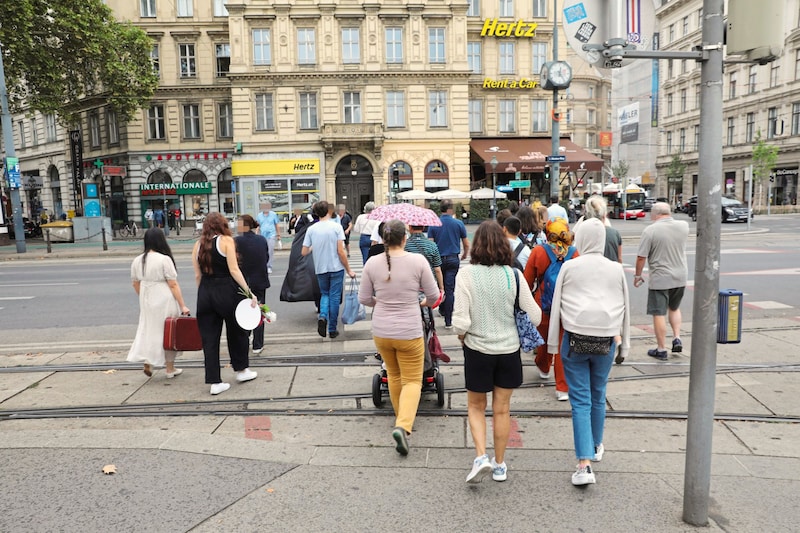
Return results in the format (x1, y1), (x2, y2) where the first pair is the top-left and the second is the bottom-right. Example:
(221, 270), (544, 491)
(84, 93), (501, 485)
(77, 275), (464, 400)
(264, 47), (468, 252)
(683, 0), (725, 526)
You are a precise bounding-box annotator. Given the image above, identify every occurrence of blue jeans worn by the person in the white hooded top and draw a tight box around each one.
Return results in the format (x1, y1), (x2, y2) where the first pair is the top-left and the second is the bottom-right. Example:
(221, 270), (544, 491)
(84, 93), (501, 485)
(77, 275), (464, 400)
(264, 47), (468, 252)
(561, 331), (617, 460)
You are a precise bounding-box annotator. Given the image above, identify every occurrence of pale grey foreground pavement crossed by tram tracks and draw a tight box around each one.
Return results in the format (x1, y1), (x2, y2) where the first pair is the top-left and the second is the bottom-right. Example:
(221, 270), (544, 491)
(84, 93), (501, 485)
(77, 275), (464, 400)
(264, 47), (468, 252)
(0, 319), (800, 532)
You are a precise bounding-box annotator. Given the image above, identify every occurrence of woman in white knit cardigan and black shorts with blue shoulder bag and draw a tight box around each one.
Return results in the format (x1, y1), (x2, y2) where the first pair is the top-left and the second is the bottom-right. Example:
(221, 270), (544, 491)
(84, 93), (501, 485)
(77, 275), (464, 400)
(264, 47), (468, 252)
(453, 221), (542, 483)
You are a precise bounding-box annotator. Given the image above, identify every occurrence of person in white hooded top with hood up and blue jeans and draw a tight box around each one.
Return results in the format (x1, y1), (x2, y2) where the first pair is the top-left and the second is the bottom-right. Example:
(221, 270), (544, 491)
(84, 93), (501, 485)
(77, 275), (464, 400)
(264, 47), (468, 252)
(546, 218), (630, 485)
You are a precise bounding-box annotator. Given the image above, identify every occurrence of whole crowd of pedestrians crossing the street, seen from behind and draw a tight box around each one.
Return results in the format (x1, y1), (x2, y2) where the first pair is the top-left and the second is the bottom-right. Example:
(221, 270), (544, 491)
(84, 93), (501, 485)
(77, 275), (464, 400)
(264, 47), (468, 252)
(128, 196), (688, 485)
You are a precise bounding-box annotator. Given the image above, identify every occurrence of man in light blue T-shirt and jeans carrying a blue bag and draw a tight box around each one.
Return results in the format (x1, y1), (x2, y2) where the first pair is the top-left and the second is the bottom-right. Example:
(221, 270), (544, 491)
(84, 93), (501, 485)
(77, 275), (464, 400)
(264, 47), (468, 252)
(300, 200), (356, 339)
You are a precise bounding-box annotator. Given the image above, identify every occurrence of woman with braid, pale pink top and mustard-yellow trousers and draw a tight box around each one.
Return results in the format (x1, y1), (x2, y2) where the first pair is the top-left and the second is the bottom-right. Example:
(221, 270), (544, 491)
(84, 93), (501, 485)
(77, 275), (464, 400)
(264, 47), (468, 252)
(358, 220), (440, 455)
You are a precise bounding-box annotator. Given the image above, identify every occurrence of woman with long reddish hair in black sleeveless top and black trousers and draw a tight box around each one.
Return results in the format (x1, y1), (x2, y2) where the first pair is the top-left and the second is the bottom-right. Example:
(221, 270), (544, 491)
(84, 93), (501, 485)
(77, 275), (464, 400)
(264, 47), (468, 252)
(192, 213), (258, 394)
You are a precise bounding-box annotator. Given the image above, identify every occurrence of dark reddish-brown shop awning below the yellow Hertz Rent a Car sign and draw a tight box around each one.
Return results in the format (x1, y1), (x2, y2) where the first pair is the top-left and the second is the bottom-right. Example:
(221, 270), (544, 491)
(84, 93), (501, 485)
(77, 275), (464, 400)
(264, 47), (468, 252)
(470, 137), (603, 173)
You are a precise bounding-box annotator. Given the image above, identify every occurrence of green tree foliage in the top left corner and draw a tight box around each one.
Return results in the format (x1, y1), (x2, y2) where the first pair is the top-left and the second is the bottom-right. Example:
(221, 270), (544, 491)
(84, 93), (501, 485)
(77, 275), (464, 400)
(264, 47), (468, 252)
(0, 0), (158, 124)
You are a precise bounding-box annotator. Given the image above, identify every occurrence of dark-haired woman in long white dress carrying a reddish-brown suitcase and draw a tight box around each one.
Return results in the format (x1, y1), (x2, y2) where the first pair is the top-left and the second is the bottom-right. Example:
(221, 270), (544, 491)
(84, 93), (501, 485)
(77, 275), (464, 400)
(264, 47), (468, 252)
(128, 228), (189, 378)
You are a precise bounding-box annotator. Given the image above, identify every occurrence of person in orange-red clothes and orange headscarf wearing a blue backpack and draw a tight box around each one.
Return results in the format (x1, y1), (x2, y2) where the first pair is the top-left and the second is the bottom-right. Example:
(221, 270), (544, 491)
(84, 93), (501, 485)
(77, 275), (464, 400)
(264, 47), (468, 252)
(525, 218), (578, 401)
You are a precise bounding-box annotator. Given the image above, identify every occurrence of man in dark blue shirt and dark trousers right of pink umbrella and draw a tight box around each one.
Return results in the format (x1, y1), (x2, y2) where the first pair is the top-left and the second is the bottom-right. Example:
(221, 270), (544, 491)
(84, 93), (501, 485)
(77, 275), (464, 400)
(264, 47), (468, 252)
(428, 200), (469, 329)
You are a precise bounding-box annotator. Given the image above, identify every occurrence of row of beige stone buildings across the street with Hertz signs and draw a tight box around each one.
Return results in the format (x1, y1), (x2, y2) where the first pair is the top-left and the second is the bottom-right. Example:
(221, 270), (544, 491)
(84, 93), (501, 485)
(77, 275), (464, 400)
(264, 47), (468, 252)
(3, 0), (611, 227)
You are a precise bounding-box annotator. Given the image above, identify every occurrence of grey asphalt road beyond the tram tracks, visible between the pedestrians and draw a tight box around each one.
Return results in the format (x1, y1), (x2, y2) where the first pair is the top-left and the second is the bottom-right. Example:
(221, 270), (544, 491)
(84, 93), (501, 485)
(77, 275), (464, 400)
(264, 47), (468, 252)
(0, 214), (800, 351)
